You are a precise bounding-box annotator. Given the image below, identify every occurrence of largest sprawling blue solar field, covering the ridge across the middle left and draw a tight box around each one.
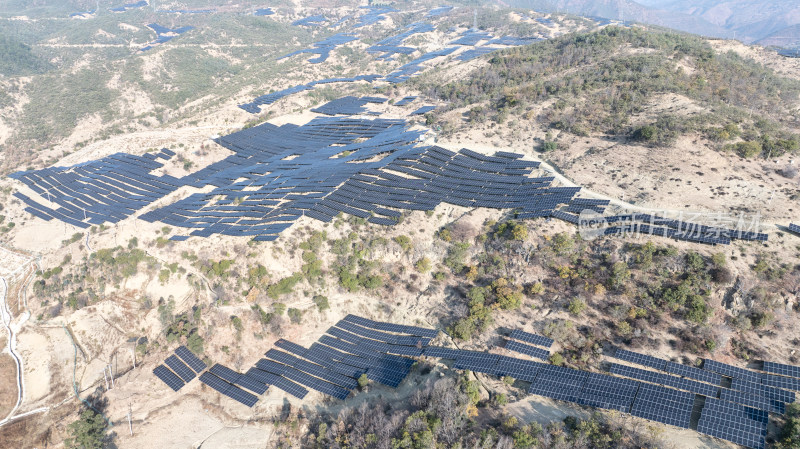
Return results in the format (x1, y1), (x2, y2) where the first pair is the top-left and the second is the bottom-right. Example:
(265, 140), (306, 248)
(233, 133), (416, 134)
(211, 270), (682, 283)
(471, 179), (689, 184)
(15, 116), (600, 241)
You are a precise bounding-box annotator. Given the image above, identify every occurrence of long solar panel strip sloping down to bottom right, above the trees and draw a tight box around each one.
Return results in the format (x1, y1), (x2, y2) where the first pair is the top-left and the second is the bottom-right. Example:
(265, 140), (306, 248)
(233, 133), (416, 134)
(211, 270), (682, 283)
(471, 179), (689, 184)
(434, 347), (781, 449)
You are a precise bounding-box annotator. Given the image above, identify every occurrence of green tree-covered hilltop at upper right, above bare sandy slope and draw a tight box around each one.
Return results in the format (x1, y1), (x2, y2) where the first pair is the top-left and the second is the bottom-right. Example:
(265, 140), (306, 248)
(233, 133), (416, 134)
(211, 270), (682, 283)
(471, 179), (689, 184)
(415, 27), (800, 157)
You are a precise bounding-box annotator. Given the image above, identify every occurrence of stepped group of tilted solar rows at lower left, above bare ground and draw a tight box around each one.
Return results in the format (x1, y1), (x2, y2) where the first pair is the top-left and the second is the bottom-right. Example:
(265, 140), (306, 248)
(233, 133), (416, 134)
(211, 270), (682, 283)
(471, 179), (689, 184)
(153, 315), (437, 407)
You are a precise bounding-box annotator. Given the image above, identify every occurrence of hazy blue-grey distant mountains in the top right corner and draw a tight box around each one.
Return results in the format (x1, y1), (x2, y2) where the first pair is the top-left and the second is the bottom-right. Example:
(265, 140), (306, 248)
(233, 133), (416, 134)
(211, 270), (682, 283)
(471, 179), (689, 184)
(502, 0), (800, 47)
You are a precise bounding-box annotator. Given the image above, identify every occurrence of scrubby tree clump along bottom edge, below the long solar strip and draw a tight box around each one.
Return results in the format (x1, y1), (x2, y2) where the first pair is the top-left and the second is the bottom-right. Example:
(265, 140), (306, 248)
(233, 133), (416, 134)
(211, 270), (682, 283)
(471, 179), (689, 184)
(301, 373), (660, 449)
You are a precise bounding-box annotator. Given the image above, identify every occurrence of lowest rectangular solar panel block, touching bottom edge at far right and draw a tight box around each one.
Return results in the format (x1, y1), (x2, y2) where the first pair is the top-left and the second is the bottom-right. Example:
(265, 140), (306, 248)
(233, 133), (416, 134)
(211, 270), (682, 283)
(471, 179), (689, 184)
(697, 398), (768, 449)
